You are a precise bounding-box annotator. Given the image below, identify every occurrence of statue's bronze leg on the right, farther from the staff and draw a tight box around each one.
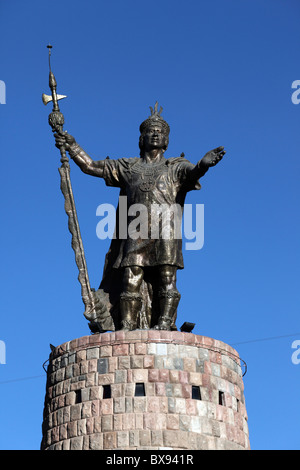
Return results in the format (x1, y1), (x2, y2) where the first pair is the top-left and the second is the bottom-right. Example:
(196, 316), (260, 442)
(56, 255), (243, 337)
(154, 265), (180, 330)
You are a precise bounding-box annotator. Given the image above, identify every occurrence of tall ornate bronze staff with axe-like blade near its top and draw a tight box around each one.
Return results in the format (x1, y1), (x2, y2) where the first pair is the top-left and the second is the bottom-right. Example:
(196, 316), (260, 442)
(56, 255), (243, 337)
(42, 44), (96, 320)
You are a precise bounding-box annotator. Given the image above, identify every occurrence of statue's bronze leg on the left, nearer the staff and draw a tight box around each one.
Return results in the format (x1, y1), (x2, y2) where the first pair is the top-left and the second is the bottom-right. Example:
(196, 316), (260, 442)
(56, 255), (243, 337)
(120, 266), (144, 331)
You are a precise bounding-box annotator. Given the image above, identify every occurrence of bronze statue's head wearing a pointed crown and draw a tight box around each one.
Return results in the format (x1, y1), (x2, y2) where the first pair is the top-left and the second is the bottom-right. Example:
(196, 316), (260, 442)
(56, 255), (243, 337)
(139, 102), (170, 155)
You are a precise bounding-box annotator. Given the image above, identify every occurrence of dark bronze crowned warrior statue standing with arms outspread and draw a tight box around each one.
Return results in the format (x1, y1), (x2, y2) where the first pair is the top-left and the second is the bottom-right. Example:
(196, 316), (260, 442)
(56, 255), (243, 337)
(44, 46), (225, 333)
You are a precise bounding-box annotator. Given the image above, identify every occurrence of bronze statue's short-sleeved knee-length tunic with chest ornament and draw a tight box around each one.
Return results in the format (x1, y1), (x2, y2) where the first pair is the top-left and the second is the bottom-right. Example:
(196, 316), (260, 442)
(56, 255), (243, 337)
(103, 156), (201, 269)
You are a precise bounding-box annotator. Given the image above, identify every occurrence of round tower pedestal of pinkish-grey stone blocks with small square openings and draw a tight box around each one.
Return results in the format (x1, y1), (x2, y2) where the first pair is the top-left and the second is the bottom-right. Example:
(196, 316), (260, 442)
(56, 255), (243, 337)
(41, 330), (250, 450)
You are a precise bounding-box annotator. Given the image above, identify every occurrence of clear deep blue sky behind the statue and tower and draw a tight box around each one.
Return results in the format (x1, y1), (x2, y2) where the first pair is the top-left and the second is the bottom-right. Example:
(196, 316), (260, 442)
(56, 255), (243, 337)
(0, 0), (300, 449)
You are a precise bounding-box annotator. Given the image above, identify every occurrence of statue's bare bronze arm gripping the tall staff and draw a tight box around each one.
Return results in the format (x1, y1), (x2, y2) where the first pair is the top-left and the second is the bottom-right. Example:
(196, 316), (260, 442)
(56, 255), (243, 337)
(54, 133), (104, 178)
